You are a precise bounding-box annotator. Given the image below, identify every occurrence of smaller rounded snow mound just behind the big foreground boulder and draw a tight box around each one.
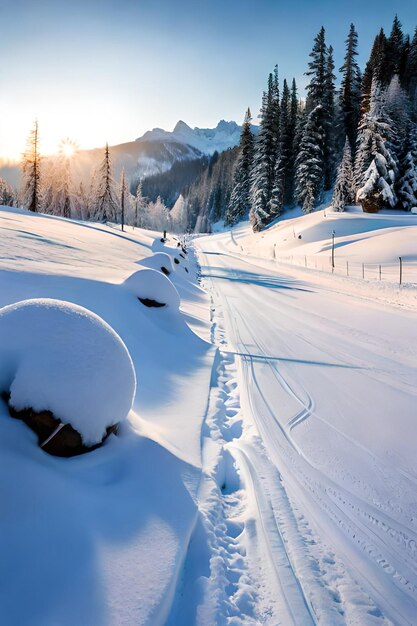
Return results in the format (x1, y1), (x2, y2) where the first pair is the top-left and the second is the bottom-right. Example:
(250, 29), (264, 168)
(125, 269), (180, 310)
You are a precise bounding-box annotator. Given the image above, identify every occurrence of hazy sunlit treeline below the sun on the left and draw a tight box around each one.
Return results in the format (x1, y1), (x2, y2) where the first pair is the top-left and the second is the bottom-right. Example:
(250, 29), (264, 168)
(0, 127), (184, 232)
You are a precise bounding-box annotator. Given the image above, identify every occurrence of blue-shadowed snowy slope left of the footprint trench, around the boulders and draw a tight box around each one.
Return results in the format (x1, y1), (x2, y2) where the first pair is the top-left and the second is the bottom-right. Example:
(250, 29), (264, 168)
(0, 207), (213, 626)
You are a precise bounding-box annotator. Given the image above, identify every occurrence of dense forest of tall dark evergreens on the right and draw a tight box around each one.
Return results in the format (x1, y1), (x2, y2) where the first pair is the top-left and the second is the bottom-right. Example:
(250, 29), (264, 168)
(224, 17), (417, 231)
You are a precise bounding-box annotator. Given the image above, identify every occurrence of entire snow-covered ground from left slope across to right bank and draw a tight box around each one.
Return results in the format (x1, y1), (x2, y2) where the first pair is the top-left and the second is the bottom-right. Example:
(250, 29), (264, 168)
(0, 208), (417, 626)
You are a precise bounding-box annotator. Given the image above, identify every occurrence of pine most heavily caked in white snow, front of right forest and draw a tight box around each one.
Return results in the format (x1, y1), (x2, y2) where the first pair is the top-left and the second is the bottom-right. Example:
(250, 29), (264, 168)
(355, 79), (397, 212)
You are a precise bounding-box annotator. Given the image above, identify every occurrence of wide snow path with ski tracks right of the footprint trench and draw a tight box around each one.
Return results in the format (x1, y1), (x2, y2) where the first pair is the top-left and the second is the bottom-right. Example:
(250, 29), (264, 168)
(195, 234), (417, 625)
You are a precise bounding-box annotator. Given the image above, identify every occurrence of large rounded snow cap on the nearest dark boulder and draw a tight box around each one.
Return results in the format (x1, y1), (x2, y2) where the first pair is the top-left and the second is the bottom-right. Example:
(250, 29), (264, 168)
(0, 299), (136, 446)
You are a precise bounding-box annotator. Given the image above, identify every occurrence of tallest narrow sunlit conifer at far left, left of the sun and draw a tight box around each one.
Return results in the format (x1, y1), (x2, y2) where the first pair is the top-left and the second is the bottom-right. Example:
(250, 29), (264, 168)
(22, 120), (41, 213)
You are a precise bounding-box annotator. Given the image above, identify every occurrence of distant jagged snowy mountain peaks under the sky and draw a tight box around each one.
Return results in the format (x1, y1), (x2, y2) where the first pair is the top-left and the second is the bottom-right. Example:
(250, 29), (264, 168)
(137, 120), (241, 154)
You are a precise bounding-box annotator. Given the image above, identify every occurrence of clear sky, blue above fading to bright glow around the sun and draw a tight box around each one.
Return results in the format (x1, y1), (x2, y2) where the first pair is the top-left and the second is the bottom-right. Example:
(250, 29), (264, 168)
(0, 0), (417, 159)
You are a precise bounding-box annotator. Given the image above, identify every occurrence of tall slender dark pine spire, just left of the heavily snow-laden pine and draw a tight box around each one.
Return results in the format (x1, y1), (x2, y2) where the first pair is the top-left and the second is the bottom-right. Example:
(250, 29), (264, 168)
(339, 24), (361, 152)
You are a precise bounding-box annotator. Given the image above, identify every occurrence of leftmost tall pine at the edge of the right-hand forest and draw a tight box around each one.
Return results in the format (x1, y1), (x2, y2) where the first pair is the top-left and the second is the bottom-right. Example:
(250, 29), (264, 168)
(225, 109), (254, 225)
